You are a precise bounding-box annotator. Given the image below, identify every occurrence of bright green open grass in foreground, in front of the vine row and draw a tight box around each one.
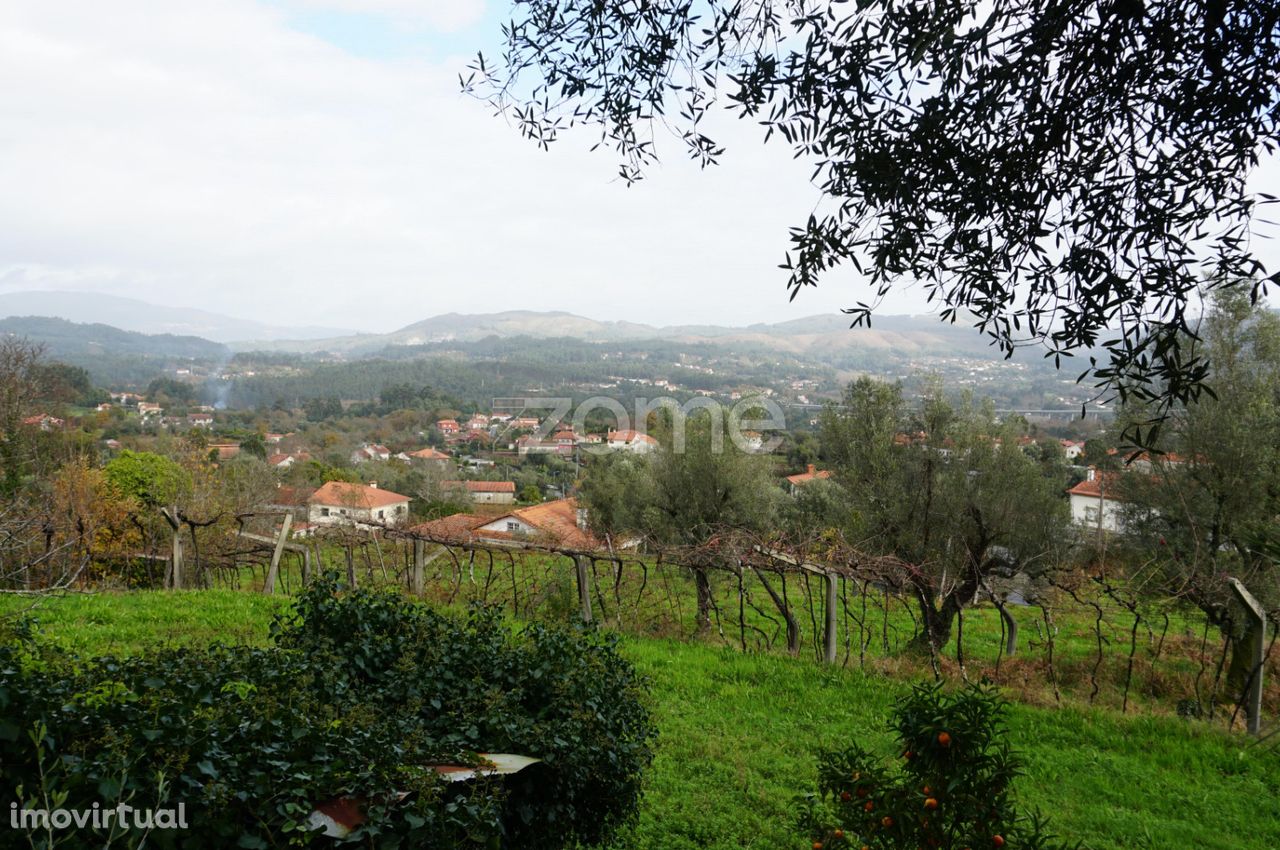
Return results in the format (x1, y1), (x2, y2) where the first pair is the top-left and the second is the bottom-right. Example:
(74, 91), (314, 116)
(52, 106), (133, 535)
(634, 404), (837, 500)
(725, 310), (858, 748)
(0, 590), (1280, 850)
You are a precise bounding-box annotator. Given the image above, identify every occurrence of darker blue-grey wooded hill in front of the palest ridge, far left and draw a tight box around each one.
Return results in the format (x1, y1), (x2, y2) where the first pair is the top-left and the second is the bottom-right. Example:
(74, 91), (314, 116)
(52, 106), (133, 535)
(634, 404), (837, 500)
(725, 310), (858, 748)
(0, 316), (230, 362)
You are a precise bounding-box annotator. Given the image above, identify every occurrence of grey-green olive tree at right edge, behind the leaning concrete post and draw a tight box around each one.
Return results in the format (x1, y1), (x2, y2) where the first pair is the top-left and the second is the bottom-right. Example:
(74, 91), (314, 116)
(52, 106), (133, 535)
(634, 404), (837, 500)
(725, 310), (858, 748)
(1119, 293), (1280, 693)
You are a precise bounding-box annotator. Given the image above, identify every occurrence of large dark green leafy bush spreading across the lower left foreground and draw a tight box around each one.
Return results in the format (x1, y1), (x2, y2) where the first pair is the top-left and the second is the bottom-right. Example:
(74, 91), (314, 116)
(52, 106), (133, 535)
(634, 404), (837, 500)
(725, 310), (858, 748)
(0, 576), (654, 849)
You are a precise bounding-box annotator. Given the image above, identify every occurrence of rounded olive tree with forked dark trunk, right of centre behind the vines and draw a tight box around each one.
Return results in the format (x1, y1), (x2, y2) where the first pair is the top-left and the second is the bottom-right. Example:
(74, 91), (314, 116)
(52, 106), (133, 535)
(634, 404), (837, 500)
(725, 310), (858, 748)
(822, 378), (1068, 649)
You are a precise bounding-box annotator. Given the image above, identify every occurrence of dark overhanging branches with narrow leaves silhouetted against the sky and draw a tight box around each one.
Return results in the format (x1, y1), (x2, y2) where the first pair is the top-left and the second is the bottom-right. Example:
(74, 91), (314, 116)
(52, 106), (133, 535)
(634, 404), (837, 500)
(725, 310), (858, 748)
(476, 0), (1280, 435)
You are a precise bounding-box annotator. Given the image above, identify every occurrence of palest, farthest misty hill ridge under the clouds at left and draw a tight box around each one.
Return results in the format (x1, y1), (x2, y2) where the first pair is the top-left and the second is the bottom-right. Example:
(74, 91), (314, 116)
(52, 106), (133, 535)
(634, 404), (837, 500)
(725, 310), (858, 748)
(0, 291), (352, 342)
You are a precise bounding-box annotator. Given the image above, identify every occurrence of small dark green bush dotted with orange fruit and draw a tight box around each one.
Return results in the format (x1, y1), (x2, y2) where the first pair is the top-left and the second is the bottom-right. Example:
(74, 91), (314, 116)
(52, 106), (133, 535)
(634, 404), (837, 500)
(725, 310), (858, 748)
(800, 685), (1061, 850)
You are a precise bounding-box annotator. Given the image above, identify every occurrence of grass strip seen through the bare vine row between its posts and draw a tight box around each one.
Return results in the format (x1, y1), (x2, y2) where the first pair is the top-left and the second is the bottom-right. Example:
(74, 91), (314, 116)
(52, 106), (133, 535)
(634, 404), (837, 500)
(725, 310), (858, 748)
(225, 541), (1254, 714)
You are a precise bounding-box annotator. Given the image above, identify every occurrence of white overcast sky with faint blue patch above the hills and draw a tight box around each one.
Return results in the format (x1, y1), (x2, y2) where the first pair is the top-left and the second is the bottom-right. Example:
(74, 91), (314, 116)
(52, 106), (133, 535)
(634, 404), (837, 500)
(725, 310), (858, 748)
(0, 0), (1275, 330)
